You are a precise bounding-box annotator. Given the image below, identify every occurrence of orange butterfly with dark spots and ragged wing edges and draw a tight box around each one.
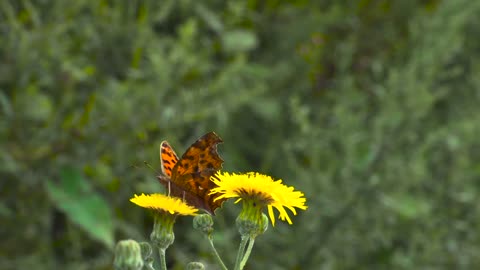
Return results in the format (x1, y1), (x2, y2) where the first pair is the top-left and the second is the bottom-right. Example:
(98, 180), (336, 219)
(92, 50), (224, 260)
(158, 132), (224, 215)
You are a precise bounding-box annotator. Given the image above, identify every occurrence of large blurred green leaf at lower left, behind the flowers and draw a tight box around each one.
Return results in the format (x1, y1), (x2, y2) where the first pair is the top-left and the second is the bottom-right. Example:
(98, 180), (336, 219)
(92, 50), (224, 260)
(46, 168), (114, 248)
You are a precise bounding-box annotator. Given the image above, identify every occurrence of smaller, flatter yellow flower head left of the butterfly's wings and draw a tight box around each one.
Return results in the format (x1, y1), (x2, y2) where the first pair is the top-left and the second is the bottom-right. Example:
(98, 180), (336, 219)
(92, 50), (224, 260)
(130, 194), (198, 216)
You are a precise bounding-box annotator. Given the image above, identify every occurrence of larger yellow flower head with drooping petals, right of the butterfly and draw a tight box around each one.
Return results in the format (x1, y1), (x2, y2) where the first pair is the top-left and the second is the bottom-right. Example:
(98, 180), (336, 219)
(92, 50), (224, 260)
(210, 172), (307, 226)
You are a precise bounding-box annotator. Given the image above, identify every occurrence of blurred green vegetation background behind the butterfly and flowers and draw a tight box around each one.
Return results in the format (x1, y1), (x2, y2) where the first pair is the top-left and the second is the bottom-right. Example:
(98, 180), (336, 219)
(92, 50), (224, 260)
(0, 0), (480, 269)
